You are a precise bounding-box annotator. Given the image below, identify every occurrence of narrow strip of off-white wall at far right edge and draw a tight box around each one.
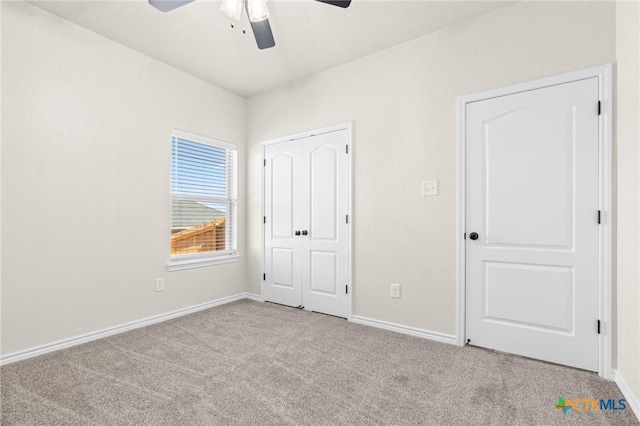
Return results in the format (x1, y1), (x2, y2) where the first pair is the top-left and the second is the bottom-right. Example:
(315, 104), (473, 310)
(616, 1), (640, 415)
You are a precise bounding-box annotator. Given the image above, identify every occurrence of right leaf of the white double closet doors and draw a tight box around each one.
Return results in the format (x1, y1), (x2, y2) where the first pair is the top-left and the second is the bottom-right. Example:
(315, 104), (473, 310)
(301, 130), (349, 317)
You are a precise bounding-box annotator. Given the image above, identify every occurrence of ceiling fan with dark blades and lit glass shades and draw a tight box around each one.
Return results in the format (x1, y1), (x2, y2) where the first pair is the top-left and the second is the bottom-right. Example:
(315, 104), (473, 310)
(149, 0), (351, 49)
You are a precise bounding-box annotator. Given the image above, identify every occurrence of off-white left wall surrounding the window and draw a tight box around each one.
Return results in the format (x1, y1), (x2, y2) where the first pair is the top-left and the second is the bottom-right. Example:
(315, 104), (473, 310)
(2, 2), (246, 355)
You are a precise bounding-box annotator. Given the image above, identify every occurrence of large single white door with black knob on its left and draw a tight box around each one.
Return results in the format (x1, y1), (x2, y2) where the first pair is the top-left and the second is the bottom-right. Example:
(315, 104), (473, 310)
(465, 78), (599, 371)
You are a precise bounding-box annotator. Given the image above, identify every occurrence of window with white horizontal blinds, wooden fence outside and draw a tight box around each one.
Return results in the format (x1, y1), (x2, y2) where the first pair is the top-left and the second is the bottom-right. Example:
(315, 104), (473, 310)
(169, 130), (238, 270)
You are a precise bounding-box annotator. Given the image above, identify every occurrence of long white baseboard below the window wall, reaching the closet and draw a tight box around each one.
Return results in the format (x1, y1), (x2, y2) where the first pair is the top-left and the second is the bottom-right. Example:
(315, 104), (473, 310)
(0, 293), (255, 365)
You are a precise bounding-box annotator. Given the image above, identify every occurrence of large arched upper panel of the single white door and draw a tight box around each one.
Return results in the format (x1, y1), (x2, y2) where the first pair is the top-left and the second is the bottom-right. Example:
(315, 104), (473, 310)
(483, 106), (576, 249)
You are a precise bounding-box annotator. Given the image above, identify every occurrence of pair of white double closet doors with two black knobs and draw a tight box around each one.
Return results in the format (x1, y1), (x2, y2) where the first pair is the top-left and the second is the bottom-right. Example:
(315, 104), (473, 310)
(262, 130), (349, 317)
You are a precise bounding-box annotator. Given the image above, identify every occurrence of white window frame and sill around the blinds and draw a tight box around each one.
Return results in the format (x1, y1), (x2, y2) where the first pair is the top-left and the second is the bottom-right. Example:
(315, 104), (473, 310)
(167, 129), (240, 272)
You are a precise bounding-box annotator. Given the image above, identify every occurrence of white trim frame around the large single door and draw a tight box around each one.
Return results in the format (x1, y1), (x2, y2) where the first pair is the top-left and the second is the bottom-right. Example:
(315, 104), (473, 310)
(456, 64), (614, 380)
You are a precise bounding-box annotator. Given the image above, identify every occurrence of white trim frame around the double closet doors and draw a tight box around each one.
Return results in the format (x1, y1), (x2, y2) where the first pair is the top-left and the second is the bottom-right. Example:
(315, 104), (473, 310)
(259, 122), (354, 321)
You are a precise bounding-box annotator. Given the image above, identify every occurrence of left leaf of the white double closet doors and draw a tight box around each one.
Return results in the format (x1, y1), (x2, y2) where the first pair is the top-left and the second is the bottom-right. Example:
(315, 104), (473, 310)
(262, 140), (303, 306)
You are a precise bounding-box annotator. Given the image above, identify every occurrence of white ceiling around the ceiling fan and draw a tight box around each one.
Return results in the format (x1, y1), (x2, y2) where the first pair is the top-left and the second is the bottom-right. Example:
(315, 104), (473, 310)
(30, 0), (512, 97)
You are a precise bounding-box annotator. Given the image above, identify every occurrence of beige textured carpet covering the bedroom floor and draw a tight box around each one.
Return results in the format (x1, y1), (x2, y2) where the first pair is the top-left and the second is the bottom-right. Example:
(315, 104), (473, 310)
(0, 301), (638, 425)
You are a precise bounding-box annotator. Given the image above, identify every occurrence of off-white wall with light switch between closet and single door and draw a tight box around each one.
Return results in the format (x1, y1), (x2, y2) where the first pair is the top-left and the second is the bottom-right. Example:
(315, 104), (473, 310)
(247, 2), (615, 334)
